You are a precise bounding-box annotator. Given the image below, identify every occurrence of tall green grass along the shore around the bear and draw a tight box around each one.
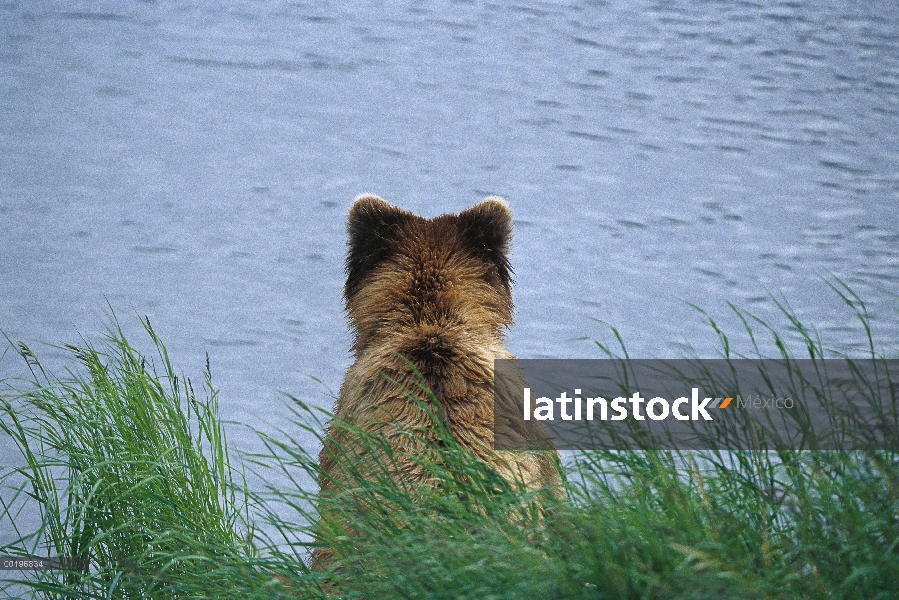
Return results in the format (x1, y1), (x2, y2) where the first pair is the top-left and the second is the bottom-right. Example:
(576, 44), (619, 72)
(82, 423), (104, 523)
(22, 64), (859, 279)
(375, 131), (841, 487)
(0, 282), (899, 599)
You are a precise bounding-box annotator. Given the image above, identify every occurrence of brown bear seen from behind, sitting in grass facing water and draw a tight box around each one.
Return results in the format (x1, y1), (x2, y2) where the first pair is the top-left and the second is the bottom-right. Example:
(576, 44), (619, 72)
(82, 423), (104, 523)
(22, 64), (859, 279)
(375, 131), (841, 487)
(313, 195), (560, 568)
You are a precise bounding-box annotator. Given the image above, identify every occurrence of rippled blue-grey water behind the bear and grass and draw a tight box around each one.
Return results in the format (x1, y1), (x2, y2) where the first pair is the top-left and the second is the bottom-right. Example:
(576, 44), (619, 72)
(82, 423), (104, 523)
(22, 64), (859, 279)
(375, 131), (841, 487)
(0, 1), (899, 510)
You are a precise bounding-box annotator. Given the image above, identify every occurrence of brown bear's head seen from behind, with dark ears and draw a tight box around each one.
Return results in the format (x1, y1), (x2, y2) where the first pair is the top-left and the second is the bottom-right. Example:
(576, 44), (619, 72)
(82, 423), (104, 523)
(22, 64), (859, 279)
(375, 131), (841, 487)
(344, 194), (512, 372)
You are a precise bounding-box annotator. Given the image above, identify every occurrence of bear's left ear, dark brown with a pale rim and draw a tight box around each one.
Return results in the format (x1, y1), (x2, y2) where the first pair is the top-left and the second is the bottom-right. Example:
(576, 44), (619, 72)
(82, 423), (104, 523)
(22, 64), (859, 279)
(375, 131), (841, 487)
(343, 194), (413, 300)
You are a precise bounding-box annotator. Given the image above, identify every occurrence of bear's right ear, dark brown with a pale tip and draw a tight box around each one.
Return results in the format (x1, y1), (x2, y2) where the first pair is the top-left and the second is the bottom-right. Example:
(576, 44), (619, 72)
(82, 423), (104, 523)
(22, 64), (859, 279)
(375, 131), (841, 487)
(459, 196), (512, 290)
